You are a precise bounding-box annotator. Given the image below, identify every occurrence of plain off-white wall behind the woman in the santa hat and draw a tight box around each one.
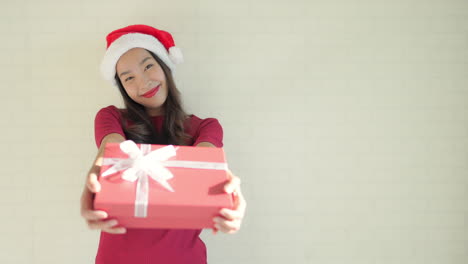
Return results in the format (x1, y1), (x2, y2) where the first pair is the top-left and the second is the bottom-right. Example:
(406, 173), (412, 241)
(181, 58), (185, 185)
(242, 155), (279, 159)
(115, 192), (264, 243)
(0, 0), (468, 264)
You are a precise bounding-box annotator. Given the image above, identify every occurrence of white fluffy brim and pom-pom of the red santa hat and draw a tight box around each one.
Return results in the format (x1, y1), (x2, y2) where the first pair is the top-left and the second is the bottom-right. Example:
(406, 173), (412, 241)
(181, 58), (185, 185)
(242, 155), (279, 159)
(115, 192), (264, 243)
(101, 33), (183, 85)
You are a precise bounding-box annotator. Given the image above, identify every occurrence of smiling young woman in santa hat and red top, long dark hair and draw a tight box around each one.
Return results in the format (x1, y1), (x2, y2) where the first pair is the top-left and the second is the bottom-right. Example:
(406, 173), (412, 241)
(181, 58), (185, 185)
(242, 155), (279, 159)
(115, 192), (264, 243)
(81, 25), (246, 264)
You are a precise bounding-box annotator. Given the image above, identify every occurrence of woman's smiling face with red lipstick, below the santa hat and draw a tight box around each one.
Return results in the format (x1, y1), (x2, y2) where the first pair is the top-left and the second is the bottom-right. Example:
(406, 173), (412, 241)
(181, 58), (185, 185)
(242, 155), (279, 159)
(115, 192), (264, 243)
(116, 48), (168, 116)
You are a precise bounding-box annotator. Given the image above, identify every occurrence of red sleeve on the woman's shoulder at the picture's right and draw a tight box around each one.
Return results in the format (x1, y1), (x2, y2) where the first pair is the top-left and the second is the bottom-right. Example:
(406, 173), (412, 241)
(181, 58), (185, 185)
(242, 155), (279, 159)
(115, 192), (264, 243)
(192, 116), (223, 148)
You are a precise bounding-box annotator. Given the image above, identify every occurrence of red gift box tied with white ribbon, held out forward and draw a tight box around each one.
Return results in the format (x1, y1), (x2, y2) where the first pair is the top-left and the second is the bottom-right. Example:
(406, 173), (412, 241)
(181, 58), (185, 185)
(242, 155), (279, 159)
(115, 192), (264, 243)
(94, 140), (233, 229)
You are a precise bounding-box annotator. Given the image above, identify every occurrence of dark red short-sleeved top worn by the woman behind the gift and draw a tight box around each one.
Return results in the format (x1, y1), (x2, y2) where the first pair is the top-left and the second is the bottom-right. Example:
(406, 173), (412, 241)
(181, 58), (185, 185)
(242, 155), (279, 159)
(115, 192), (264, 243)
(94, 105), (223, 264)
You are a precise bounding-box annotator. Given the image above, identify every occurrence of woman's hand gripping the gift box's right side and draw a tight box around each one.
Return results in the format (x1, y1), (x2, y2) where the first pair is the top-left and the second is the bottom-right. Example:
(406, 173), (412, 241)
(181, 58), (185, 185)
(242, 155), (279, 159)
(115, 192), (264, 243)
(213, 170), (247, 234)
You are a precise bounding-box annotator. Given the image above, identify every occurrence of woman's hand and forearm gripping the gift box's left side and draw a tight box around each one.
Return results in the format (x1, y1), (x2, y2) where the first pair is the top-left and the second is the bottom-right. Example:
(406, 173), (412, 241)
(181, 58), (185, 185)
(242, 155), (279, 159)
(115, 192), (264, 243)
(81, 137), (127, 234)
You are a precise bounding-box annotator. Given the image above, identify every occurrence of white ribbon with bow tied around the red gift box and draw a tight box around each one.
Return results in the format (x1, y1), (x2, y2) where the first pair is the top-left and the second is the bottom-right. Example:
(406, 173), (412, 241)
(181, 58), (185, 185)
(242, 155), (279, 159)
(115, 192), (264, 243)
(101, 140), (227, 217)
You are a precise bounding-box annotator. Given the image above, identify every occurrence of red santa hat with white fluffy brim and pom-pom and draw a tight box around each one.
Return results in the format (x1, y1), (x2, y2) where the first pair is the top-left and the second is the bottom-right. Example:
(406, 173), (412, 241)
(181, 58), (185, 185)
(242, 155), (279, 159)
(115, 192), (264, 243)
(101, 25), (183, 85)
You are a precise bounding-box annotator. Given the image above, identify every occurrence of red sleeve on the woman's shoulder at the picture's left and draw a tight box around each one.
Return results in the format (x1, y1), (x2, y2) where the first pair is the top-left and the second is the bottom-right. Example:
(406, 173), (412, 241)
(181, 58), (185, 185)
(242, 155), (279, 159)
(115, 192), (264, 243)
(94, 105), (125, 148)
